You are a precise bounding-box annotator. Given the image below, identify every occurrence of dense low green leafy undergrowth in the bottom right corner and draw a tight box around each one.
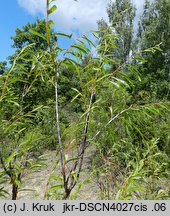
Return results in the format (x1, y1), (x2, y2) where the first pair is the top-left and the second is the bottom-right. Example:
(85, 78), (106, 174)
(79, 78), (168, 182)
(93, 139), (169, 200)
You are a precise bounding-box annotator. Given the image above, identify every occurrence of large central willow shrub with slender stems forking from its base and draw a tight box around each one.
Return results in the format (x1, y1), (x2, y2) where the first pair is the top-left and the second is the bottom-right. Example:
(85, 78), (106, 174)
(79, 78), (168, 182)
(32, 1), (168, 199)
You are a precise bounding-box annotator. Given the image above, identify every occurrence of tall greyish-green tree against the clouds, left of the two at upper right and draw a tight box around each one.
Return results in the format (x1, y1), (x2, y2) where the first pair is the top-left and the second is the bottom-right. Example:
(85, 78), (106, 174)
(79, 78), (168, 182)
(98, 0), (135, 64)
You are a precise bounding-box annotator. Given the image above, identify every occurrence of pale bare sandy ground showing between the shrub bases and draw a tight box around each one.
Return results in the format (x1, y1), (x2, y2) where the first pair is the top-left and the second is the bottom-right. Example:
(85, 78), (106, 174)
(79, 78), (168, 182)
(0, 148), (97, 200)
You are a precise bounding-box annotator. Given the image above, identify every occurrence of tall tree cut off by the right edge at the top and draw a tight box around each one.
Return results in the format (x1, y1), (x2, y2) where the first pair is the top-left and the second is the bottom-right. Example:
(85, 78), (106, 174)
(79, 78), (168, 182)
(137, 0), (170, 101)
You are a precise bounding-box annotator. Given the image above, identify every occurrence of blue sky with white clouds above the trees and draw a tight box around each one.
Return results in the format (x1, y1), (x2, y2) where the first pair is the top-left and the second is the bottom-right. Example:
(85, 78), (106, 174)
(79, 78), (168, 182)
(0, 0), (144, 61)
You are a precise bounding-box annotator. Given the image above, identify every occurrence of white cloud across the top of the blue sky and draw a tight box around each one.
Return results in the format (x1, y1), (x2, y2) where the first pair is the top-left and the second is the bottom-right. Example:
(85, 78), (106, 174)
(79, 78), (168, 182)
(18, 0), (144, 32)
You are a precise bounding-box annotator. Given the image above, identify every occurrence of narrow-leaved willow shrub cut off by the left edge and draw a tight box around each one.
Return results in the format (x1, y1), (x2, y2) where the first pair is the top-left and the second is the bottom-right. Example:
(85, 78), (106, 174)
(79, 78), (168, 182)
(0, 44), (48, 200)
